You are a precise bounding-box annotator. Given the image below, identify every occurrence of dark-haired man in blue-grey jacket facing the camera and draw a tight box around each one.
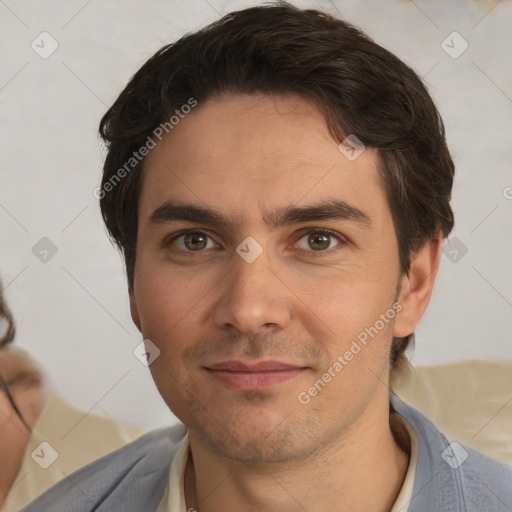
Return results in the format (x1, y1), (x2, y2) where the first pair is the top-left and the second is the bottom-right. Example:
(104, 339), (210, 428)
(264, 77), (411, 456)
(25, 3), (512, 512)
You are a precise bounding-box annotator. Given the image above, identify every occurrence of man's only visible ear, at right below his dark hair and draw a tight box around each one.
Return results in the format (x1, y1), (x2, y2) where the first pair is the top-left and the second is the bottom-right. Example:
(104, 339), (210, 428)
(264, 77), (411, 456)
(393, 231), (443, 338)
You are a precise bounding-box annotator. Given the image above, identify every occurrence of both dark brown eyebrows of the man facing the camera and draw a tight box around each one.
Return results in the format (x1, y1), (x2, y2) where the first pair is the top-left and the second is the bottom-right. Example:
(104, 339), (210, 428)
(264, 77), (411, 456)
(148, 199), (372, 230)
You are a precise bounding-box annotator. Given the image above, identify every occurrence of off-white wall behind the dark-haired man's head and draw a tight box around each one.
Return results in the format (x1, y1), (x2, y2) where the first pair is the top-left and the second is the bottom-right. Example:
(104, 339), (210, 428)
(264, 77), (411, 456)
(0, 0), (512, 427)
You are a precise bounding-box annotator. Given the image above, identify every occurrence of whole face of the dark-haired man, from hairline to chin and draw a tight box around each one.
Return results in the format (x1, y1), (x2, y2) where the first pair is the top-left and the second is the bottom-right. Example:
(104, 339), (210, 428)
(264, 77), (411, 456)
(131, 95), (408, 462)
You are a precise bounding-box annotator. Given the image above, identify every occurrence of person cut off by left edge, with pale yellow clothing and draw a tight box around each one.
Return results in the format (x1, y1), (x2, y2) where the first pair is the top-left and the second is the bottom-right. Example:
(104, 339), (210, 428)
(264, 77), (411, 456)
(0, 285), (144, 512)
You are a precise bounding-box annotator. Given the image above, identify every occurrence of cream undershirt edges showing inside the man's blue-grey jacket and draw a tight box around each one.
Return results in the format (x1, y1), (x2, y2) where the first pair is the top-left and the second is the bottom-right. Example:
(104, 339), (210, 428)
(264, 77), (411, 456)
(156, 415), (418, 512)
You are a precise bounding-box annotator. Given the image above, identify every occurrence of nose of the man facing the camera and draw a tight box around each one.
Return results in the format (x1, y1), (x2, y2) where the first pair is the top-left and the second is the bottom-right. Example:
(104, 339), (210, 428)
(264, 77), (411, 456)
(212, 251), (292, 336)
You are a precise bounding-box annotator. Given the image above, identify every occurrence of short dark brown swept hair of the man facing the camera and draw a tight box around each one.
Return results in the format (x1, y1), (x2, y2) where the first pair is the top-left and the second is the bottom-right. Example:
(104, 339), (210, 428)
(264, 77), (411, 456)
(98, 2), (454, 367)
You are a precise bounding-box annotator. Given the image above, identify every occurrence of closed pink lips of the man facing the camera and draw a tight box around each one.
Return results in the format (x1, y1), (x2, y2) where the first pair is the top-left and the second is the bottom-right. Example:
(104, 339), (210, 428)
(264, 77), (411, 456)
(205, 361), (307, 391)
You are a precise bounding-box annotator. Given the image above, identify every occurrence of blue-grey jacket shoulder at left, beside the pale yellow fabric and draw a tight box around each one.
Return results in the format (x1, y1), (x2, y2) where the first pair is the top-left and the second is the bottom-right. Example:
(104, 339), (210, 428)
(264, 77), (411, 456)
(23, 424), (186, 512)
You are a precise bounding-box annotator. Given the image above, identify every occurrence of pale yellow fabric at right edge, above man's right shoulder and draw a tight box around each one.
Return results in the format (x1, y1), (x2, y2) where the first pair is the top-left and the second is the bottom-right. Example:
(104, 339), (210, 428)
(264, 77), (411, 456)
(391, 360), (512, 465)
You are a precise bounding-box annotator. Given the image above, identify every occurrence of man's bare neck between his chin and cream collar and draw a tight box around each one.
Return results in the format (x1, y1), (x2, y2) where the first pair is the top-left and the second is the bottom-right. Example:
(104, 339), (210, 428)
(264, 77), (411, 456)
(185, 400), (409, 512)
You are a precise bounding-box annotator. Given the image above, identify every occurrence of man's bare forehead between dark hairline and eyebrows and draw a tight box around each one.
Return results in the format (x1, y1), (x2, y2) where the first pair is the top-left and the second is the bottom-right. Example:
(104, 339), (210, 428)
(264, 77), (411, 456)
(139, 94), (387, 228)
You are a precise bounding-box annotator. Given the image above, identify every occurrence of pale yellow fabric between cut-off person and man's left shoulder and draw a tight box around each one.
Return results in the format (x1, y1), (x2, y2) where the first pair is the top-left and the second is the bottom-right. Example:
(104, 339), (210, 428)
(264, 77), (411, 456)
(1, 391), (145, 512)
